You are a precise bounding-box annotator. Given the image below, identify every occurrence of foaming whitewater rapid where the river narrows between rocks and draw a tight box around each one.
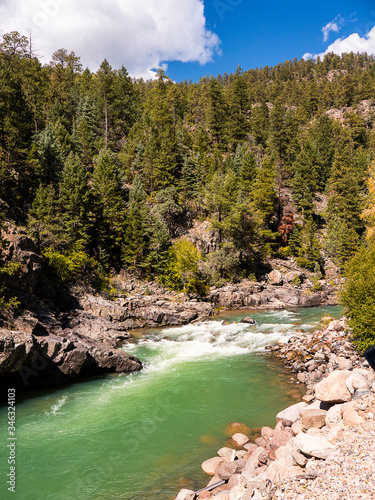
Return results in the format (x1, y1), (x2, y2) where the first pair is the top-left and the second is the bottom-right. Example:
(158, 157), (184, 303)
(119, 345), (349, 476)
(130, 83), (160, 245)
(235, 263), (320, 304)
(124, 310), (313, 373)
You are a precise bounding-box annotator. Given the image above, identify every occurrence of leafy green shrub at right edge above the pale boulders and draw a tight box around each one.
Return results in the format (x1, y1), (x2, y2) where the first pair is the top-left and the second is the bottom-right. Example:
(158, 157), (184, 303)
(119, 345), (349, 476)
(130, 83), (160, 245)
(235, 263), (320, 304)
(340, 242), (375, 352)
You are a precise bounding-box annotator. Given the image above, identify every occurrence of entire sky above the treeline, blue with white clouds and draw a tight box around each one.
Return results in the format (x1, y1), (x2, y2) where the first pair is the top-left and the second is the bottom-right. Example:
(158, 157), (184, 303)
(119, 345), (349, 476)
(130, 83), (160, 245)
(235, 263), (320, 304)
(0, 0), (375, 81)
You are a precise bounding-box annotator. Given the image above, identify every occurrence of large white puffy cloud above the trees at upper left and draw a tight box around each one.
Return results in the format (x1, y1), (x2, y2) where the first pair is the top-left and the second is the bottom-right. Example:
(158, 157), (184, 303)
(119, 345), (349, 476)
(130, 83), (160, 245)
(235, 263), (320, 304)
(0, 0), (220, 78)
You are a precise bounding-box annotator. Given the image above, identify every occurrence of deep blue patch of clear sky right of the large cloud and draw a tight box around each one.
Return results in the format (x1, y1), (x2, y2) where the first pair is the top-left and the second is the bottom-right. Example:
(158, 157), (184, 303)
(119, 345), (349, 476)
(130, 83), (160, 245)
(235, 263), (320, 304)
(167, 0), (375, 81)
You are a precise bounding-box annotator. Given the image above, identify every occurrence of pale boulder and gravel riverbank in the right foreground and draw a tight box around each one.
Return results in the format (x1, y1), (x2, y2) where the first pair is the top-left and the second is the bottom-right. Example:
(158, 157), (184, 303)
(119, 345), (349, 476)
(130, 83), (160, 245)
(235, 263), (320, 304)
(176, 318), (375, 500)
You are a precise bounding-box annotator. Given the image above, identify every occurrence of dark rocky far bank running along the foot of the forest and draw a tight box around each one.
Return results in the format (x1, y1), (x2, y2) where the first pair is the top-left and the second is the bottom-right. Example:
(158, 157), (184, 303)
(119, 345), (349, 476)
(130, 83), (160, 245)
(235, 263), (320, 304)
(0, 228), (340, 394)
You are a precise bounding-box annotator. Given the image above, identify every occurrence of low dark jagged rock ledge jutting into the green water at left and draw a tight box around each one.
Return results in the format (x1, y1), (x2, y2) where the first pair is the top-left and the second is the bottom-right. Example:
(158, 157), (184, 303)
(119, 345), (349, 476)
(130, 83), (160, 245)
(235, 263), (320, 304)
(0, 330), (142, 396)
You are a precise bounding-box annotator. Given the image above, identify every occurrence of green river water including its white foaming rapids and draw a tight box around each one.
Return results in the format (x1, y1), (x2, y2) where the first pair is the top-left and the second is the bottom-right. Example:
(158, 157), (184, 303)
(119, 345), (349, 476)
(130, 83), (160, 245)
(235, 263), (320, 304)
(0, 307), (340, 500)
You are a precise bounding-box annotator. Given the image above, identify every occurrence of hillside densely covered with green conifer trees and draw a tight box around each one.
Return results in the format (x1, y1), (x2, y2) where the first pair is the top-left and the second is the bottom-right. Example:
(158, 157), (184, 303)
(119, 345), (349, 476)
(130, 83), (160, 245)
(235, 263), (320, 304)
(0, 32), (375, 293)
